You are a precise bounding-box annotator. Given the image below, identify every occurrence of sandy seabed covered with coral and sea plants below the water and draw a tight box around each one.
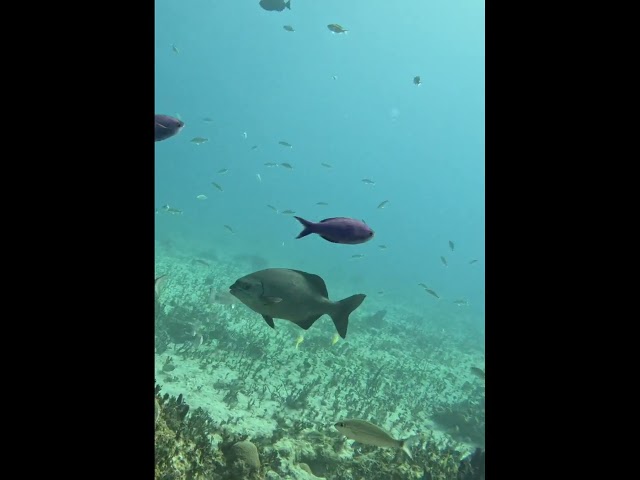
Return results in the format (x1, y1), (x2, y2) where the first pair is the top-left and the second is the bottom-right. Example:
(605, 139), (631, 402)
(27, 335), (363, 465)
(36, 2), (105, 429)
(155, 247), (484, 480)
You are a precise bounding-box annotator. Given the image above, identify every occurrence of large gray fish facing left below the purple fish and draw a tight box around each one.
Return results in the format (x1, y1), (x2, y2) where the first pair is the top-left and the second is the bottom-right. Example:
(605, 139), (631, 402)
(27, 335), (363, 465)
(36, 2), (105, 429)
(229, 268), (366, 338)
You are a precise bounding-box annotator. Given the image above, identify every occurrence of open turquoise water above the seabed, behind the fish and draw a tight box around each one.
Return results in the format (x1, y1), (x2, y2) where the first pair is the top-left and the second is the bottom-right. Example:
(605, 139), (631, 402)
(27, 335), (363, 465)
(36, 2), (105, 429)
(155, 0), (485, 476)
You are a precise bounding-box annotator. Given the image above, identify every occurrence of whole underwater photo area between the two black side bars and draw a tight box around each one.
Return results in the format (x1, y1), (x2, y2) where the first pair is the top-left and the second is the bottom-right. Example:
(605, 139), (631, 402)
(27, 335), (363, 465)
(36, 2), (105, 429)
(154, 0), (485, 480)
